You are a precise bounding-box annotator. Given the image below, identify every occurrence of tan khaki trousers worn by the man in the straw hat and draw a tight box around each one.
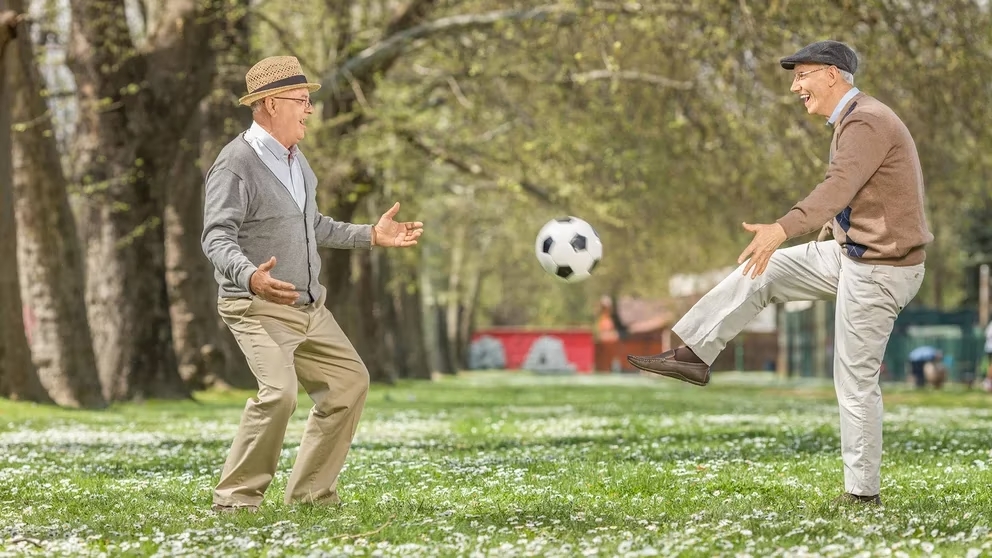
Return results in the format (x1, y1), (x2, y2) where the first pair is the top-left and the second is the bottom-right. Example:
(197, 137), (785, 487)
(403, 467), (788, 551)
(214, 296), (369, 506)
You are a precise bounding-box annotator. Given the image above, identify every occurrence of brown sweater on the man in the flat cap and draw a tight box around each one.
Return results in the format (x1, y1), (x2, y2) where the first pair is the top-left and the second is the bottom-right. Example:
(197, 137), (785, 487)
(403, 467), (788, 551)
(778, 93), (933, 266)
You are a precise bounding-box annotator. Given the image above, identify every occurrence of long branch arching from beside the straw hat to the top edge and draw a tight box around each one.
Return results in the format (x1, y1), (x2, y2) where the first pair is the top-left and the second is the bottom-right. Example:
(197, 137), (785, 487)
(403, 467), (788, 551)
(317, 0), (678, 98)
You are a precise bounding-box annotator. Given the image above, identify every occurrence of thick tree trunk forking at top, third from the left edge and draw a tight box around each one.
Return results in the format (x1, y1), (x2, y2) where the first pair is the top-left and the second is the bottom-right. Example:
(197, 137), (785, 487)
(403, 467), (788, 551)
(69, 0), (231, 400)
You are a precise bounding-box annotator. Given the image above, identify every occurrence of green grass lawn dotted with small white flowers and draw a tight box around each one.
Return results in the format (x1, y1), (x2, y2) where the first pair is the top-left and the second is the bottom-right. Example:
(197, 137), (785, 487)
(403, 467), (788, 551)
(0, 373), (992, 557)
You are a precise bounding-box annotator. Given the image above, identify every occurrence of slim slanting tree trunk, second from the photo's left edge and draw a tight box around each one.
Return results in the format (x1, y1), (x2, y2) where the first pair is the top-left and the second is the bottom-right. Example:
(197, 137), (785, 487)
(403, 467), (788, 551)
(7, 0), (106, 408)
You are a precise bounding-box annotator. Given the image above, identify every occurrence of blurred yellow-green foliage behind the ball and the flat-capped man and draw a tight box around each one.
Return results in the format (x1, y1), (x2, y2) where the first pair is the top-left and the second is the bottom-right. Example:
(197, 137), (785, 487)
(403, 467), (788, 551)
(250, 0), (992, 323)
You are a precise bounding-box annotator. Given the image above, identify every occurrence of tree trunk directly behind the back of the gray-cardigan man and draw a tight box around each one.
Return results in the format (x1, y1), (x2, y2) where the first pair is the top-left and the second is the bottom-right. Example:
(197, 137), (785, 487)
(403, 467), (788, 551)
(163, 2), (257, 389)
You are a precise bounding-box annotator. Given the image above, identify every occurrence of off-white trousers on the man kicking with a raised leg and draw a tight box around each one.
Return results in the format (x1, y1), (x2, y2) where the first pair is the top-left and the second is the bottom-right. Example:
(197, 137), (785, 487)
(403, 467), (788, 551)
(672, 240), (924, 496)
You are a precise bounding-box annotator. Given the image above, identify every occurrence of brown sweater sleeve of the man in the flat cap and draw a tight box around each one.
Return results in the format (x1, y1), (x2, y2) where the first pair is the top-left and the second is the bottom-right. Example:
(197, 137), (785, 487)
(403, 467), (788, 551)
(778, 114), (891, 238)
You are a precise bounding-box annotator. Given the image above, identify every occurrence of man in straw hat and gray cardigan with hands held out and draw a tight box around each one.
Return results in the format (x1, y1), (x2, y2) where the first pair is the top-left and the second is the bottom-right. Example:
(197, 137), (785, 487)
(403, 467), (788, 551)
(201, 56), (423, 511)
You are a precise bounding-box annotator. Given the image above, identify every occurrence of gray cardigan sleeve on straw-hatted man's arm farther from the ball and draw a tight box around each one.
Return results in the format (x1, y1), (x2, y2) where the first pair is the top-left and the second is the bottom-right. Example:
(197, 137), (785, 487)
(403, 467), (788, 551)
(200, 168), (258, 293)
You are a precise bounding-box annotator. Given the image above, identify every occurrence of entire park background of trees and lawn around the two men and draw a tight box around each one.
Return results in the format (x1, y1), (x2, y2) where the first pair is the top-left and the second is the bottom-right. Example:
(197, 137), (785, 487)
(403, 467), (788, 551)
(0, 0), (992, 557)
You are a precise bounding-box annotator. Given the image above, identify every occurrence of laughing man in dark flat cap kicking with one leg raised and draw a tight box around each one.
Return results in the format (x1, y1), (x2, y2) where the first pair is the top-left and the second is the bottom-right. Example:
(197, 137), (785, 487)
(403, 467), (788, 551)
(628, 41), (933, 504)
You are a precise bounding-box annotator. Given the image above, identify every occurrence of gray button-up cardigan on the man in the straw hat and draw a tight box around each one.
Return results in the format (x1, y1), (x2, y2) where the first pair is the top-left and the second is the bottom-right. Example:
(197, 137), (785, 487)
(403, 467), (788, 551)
(200, 134), (372, 305)
